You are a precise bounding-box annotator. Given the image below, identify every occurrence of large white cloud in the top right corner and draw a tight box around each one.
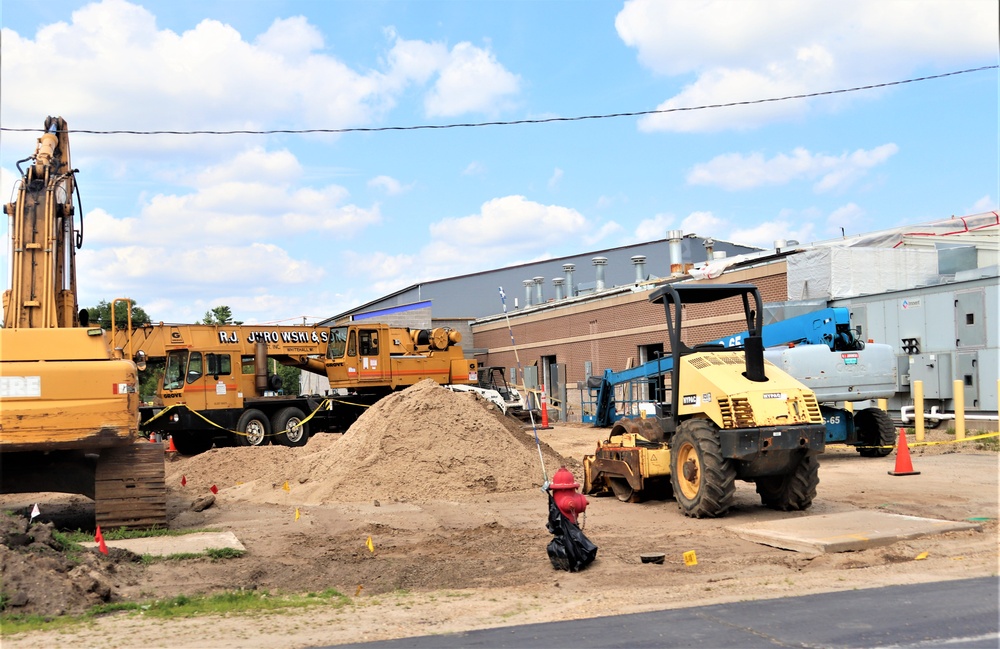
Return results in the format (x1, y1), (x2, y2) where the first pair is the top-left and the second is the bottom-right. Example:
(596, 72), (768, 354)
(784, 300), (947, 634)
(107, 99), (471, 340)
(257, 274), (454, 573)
(615, 0), (998, 131)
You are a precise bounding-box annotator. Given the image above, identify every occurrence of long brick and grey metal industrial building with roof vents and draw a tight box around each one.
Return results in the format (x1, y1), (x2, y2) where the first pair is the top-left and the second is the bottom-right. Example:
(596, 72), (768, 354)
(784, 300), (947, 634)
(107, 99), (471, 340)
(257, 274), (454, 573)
(318, 212), (1000, 422)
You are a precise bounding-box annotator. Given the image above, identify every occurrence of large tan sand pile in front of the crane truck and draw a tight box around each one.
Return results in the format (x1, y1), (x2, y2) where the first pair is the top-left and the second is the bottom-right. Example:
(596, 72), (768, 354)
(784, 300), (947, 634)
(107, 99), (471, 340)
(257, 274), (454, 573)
(167, 380), (567, 505)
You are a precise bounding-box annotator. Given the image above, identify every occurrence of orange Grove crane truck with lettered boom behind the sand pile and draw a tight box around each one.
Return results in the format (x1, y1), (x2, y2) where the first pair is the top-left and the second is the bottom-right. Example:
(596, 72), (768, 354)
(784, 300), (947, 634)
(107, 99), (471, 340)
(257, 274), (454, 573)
(115, 323), (477, 455)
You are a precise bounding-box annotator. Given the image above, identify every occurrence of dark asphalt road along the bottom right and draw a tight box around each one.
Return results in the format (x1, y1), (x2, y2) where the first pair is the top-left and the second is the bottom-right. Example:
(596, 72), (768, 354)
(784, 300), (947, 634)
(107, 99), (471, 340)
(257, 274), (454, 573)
(328, 577), (1000, 649)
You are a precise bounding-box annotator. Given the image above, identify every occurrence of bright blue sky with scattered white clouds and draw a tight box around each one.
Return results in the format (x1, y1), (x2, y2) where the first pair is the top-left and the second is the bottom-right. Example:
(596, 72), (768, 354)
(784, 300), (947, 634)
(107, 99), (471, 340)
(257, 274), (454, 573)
(0, 0), (1000, 324)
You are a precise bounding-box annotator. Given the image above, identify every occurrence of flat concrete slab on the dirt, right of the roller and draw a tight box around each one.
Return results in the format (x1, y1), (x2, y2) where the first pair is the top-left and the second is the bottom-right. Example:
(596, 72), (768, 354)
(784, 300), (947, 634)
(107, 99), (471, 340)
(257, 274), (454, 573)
(729, 510), (981, 554)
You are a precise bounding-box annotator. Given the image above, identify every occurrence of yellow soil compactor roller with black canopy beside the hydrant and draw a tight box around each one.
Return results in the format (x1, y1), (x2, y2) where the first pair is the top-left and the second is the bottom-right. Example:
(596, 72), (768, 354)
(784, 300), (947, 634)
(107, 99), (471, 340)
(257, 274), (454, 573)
(583, 284), (826, 518)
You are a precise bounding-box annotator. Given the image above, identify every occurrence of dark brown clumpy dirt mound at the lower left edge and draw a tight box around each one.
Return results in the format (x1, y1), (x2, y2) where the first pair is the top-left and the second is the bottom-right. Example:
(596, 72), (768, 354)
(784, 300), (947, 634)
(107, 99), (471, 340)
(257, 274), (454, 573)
(0, 514), (140, 617)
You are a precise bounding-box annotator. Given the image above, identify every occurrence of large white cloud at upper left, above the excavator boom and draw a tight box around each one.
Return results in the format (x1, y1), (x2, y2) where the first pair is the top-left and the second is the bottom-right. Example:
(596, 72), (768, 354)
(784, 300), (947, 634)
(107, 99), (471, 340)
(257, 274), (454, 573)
(0, 0), (520, 156)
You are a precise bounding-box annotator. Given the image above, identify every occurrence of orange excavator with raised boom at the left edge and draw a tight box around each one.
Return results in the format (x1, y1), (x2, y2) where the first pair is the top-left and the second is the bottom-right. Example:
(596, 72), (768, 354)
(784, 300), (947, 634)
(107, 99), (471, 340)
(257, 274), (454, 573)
(0, 117), (166, 528)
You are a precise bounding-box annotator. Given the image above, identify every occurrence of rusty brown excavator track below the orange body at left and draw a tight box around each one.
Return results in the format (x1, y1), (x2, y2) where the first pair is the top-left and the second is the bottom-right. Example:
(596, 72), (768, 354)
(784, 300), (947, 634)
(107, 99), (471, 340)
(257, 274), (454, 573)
(94, 443), (167, 529)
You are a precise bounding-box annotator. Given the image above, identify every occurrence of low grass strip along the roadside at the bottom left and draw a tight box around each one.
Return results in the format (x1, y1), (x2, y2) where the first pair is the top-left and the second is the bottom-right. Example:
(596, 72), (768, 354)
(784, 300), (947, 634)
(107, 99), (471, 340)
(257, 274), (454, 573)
(0, 588), (350, 635)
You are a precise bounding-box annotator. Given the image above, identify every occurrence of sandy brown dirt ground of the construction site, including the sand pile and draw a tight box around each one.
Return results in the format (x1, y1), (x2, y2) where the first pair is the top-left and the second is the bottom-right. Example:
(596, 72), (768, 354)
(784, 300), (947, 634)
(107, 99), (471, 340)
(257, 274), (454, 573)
(0, 385), (998, 649)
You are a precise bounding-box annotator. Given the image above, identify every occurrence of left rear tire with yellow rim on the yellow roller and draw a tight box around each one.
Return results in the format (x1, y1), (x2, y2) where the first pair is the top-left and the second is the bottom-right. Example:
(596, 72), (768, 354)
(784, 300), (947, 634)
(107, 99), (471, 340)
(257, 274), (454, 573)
(670, 419), (736, 518)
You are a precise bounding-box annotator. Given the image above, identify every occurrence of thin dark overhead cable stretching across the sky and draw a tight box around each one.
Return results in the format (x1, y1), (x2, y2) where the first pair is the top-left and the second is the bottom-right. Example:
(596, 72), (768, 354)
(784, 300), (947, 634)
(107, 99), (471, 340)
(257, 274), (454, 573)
(0, 65), (1000, 135)
